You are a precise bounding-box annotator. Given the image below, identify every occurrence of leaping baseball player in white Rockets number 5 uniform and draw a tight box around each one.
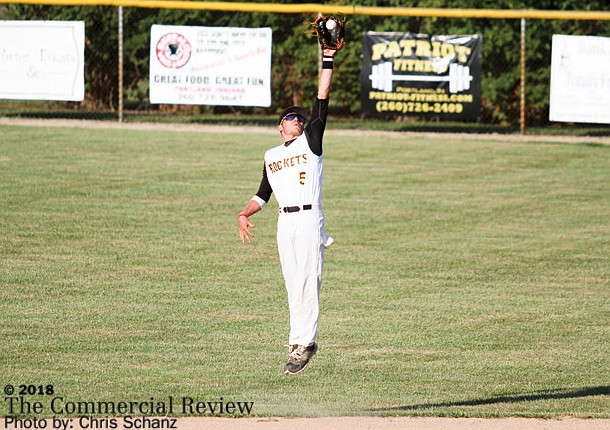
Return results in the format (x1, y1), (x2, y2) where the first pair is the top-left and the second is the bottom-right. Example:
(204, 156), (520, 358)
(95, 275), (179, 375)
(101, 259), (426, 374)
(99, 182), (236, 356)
(237, 49), (337, 375)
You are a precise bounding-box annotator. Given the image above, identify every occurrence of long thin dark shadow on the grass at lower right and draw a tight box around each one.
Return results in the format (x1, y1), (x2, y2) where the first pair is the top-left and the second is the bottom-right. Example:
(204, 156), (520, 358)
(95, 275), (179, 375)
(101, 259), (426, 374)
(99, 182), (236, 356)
(371, 385), (610, 412)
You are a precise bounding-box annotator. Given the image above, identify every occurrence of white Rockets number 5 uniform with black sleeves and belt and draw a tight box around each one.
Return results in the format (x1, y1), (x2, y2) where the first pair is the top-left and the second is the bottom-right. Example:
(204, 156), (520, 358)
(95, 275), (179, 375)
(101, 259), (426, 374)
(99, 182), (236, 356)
(253, 98), (332, 346)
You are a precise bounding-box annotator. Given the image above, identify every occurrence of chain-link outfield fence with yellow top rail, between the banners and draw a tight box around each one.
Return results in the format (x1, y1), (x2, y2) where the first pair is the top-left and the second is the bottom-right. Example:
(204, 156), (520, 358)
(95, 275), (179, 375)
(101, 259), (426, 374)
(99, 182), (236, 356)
(0, 0), (610, 133)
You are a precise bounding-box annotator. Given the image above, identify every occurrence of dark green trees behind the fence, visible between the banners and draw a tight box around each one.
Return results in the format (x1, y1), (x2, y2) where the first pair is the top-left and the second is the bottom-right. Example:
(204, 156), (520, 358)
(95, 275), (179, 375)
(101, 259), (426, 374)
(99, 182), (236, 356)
(0, 0), (610, 124)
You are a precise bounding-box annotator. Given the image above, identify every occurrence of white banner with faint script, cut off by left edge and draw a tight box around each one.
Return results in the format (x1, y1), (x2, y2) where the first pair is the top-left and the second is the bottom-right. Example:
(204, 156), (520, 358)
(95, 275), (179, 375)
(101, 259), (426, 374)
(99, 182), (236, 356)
(0, 21), (85, 101)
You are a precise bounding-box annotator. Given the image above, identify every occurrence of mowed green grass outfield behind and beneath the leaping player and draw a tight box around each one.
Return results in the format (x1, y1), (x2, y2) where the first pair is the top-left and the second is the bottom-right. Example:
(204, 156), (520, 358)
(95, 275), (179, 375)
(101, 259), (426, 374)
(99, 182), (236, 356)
(0, 126), (610, 418)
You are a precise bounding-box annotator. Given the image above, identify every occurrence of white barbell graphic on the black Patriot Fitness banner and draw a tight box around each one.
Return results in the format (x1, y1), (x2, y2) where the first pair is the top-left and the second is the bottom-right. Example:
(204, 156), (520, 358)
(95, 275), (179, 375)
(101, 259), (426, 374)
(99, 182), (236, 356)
(369, 61), (472, 93)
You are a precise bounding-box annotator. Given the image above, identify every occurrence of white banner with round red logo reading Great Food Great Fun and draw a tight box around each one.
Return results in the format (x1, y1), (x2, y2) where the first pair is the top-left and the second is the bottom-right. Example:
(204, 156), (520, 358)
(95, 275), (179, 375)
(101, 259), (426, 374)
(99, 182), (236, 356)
(150, 25), (271, 107)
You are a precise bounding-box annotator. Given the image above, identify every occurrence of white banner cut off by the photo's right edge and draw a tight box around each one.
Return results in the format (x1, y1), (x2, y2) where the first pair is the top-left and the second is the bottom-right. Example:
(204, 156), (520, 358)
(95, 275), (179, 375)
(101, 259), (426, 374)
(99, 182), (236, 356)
(549, 34), (610, 124)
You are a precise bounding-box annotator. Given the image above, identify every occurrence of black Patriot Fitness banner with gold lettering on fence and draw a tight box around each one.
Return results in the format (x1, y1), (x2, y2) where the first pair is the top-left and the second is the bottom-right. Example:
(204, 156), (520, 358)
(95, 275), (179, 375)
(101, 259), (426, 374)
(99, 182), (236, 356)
(361, 32), (482, 121)
